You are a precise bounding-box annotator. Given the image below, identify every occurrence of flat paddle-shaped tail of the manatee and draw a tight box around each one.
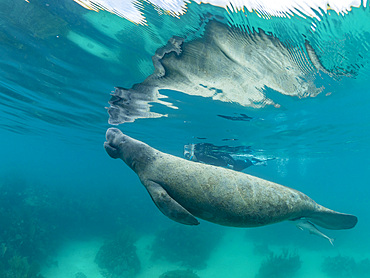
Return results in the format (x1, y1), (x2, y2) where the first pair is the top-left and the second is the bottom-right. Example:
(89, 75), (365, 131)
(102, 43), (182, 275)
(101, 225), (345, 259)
(307, 207), (357, 230)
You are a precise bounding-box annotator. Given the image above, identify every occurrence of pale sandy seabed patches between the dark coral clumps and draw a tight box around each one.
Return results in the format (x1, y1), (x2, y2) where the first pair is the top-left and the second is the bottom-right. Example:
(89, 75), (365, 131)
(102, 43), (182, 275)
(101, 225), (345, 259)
(42, 230), (358, 278)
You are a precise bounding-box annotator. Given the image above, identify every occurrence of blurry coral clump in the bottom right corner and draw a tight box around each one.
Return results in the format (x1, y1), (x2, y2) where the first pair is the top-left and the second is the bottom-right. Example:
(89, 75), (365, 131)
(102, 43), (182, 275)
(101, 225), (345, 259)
(321, 255), (370, 278)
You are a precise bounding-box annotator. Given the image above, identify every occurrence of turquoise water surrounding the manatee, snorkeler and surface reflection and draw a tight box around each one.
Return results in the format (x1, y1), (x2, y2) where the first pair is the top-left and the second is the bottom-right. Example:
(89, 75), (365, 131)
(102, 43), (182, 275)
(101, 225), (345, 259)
(0, 0), (370, 278)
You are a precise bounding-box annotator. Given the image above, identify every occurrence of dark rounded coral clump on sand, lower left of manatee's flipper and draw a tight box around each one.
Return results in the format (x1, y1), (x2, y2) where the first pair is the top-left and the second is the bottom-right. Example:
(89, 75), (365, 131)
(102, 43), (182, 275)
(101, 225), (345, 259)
(95, 228), (141, 278)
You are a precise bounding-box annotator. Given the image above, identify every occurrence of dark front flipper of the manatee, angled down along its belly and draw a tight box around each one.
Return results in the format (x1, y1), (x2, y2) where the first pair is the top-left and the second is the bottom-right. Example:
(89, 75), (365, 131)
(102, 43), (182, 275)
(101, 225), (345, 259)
(143, 180), (199, 225)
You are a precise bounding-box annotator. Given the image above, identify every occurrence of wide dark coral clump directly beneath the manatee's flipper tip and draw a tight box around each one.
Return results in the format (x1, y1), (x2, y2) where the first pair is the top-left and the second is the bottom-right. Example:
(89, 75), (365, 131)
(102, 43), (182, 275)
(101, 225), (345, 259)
(152, 225), (221, 269)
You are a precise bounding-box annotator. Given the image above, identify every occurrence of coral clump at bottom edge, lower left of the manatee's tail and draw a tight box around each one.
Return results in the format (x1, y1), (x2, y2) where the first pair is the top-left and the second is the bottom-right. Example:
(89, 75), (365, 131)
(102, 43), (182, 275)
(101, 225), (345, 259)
(256, 249), (302, 278)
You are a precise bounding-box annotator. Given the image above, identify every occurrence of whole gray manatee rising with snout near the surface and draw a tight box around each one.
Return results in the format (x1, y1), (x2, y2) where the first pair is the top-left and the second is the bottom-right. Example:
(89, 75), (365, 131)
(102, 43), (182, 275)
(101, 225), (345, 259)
(104, 128), (357, 229)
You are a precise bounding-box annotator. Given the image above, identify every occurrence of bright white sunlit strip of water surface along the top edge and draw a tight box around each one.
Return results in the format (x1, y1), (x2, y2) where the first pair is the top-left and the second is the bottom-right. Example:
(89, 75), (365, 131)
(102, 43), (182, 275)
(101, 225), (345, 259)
(74, 0), (367, 24)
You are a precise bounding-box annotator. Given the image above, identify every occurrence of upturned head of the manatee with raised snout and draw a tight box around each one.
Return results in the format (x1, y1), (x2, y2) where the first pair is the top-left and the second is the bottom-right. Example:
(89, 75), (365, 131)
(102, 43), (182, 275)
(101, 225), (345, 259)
(104, 128), (154, 173)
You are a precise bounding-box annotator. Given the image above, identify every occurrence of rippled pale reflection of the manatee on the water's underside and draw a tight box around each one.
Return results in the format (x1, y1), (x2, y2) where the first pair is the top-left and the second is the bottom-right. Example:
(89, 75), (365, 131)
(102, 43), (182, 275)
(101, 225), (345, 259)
(108, 21), (326, 124)
